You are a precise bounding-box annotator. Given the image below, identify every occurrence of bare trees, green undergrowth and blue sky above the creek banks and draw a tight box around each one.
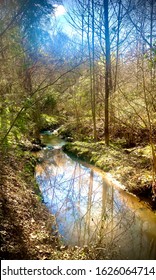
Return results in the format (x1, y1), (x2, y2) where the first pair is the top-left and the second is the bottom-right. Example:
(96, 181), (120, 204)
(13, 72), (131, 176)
(0, 0), (156, 166)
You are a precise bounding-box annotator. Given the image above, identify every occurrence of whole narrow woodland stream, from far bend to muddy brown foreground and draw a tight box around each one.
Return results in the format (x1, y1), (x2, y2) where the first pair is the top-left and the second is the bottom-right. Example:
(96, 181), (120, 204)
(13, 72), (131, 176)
(36, 134), (156, 259)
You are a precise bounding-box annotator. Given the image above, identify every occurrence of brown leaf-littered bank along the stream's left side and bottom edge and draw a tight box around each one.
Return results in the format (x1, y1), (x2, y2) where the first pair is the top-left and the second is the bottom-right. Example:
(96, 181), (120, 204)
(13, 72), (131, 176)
(0, 150), (117, 260)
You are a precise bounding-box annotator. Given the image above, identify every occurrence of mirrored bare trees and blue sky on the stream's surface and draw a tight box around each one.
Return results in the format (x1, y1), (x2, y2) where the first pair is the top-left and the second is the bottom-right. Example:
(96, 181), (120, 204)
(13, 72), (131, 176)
(37, 150), (134, 249)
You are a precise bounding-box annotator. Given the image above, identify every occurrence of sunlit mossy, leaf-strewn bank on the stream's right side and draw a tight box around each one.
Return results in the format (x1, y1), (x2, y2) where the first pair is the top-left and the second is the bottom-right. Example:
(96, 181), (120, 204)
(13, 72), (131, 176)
(63, 141), (156, 210)
